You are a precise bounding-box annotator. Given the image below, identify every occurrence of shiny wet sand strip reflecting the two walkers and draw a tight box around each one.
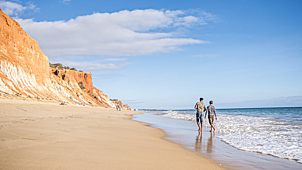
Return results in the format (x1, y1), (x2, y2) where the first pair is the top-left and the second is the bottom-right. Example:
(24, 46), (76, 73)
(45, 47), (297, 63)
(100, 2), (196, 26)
(134, 113), (302, 170)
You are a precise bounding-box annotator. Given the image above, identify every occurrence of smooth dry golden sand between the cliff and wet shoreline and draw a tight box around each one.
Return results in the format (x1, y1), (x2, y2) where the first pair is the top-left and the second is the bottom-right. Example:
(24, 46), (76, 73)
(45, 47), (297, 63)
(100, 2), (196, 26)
(0, 99), (223, 170)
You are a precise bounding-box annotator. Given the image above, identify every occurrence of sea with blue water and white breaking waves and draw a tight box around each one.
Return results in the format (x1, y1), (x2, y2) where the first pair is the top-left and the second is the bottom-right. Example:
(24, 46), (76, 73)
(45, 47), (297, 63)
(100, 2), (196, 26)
(143, 107), (302, 163)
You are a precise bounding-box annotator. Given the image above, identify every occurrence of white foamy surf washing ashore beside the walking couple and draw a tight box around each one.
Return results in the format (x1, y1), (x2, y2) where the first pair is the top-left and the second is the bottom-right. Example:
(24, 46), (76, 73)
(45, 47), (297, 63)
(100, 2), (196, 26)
(157, 110), (302, 163)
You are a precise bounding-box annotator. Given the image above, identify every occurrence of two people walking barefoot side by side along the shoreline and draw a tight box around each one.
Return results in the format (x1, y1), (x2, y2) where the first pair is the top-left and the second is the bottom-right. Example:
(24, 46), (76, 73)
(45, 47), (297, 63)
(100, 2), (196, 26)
(195, 98), (217, 133)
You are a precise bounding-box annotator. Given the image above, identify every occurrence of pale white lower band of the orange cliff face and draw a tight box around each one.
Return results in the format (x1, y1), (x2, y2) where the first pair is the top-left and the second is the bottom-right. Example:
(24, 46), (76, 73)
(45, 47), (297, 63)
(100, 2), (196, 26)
(0, 61), (115, 107)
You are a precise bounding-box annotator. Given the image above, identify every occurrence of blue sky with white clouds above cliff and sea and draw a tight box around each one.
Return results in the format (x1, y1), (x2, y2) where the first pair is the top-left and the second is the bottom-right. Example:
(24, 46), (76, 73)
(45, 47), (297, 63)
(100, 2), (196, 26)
(0, 0), (302, 109)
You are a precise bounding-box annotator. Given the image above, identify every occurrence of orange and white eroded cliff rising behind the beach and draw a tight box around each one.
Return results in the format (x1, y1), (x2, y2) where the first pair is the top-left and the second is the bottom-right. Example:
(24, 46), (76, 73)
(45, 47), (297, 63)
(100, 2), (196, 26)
(0, 9), (129, 107)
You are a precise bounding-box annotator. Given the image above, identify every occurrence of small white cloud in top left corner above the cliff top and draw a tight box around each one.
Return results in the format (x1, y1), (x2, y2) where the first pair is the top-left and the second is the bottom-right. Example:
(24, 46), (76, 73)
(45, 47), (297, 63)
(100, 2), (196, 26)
(0, 1), (37, 16)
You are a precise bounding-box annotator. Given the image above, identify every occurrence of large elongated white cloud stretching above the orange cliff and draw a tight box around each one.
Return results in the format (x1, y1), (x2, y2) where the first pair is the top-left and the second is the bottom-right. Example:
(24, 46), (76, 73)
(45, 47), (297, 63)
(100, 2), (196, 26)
(17, 9), (207, 58)
